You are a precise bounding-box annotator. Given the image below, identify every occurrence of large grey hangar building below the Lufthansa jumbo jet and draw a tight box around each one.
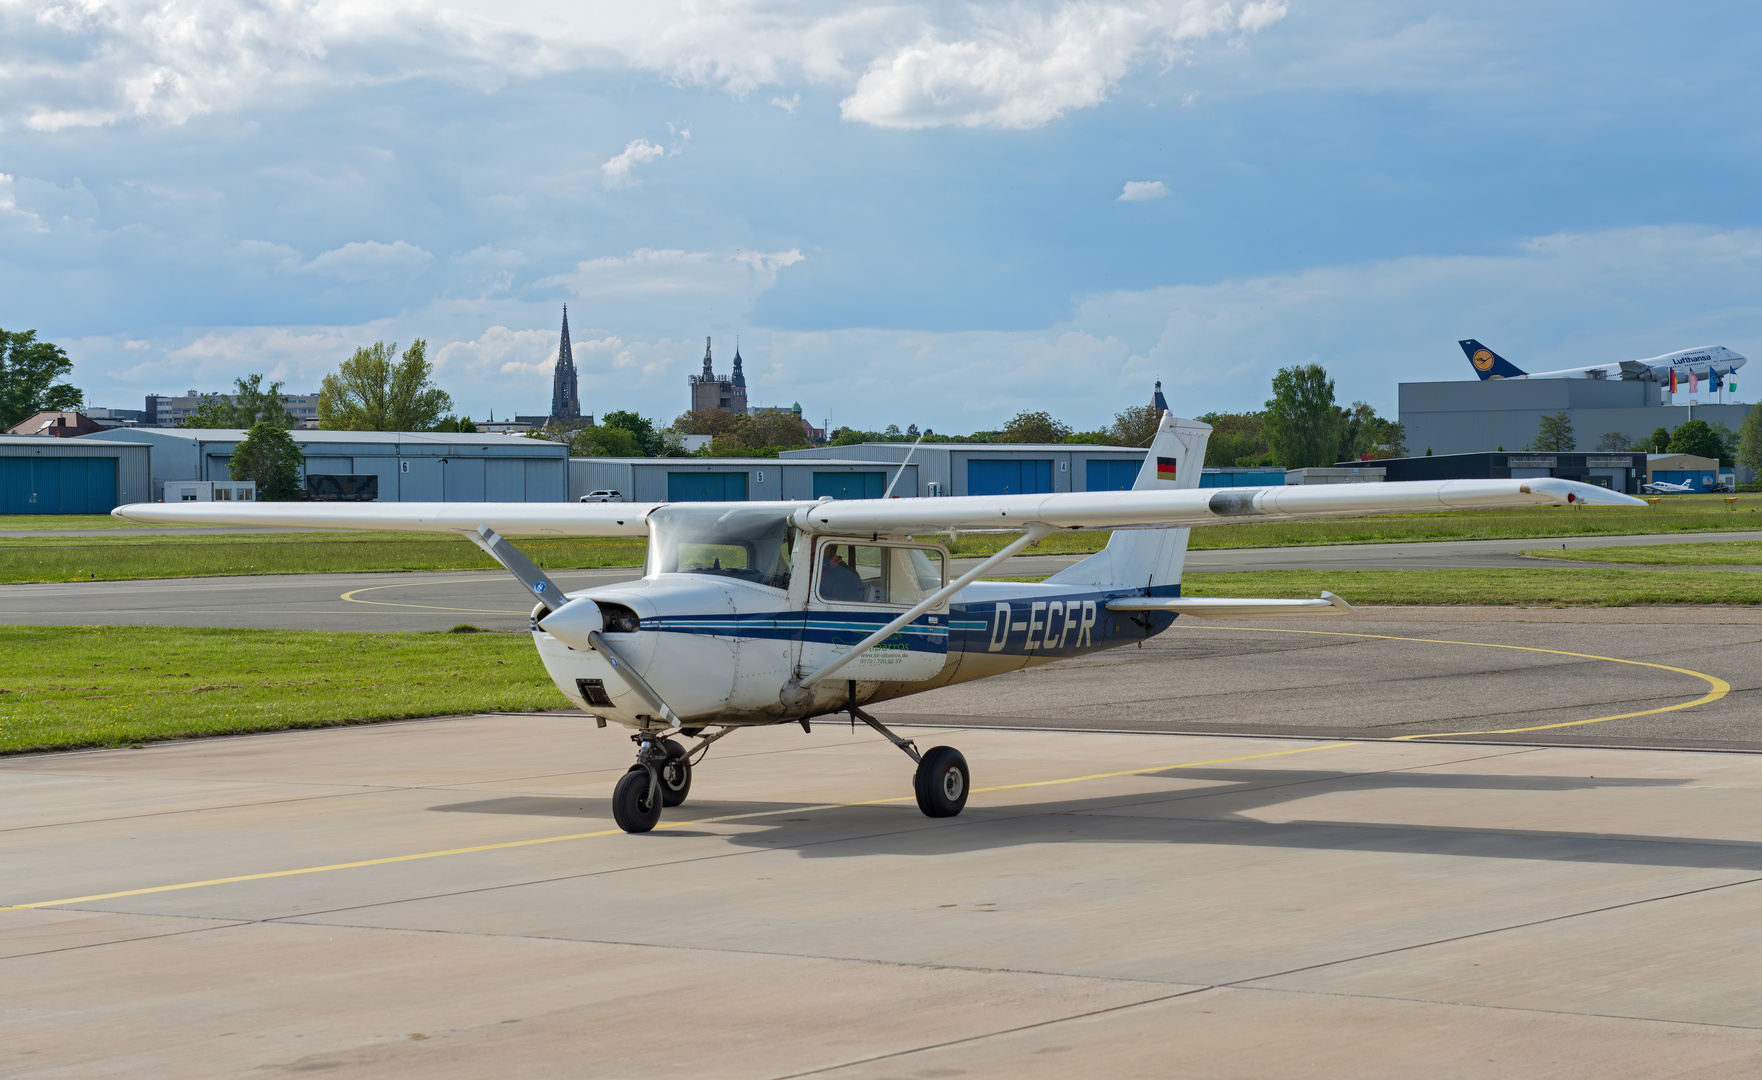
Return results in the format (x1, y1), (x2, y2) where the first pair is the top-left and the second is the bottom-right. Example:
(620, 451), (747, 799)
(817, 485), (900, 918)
(1388, 379), (1750, 458)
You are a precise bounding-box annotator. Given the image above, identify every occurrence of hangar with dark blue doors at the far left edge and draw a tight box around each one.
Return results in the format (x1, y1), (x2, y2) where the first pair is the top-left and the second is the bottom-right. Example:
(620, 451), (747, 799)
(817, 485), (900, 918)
(0, 435), (153, 514)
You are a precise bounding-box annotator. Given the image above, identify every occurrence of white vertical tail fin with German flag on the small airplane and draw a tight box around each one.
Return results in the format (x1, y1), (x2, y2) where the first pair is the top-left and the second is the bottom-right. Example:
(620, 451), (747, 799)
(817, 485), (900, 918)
(1047, 412), (1210, 595)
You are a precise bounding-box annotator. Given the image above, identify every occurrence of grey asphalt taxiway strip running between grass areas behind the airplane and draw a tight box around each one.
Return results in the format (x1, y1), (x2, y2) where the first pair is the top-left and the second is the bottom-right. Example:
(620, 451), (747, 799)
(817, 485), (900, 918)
(0, 532), (1762, 631)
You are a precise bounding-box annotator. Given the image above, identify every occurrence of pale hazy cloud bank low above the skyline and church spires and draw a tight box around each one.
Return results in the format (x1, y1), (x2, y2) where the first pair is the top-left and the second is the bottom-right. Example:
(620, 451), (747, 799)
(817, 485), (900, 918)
(60, 226), (1762, 432)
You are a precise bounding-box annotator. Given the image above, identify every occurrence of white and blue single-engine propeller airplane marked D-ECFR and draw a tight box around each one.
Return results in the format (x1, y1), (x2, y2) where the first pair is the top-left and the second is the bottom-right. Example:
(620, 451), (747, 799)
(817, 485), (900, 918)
(113, 412), (1646, 832)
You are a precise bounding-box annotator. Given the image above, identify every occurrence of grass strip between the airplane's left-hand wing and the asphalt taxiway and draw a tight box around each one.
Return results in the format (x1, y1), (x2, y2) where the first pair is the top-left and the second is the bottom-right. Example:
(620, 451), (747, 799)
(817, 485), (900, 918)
(0, 532), (645, 583)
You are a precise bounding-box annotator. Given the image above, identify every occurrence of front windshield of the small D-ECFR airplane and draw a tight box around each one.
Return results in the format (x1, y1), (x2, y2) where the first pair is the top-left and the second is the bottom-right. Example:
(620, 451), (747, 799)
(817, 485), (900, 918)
(645, 507), (795, 590)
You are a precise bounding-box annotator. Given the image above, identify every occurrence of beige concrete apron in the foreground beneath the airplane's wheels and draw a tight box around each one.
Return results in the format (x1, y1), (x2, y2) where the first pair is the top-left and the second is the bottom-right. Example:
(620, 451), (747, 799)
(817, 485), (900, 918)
(0, 715), (1762, 1078)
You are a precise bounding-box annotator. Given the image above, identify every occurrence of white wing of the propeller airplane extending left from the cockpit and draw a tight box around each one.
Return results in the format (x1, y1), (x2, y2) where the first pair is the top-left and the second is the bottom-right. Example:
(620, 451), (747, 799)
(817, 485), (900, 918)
(111, 502), (662, 536)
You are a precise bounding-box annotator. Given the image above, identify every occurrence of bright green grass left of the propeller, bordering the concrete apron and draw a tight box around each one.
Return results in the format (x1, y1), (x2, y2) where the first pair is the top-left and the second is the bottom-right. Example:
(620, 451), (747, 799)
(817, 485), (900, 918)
(0, 627), (569, 752)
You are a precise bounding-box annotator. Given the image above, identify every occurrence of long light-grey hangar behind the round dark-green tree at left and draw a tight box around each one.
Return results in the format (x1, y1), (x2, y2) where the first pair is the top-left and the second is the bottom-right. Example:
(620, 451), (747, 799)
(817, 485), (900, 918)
(82, 428), (569, 502)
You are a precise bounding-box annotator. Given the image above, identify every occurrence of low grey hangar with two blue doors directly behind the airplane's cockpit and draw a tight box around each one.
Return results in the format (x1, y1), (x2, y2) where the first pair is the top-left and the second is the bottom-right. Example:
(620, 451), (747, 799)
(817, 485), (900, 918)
(569, 458), (918, 502)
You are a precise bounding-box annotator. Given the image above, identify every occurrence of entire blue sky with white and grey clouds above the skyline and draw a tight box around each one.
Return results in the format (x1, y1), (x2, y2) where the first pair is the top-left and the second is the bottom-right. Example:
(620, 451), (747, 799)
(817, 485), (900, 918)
(0, 0), (1762, 432)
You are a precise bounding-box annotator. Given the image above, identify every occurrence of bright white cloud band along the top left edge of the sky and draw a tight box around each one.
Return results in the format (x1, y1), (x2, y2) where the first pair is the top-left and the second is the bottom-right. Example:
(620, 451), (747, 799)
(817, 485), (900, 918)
(0, 0), (1286, 131)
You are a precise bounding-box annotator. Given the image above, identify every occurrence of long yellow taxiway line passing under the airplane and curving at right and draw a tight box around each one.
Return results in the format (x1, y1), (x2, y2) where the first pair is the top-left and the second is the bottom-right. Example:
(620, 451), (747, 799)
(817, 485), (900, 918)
(0, 627), (1732, 911)
